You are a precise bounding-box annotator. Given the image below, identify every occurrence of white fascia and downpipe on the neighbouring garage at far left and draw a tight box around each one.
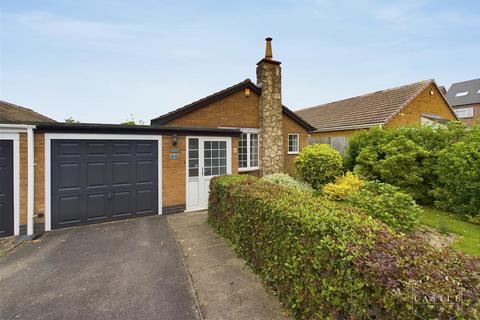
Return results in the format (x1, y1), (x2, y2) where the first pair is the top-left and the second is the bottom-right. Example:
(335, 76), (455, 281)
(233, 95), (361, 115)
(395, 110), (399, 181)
(0, 123), (36, 237)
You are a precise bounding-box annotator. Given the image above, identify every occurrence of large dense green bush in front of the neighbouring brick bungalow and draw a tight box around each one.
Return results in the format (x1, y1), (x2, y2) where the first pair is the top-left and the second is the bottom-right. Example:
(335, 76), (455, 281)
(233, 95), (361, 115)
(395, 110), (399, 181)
(345, 122), (472, 204)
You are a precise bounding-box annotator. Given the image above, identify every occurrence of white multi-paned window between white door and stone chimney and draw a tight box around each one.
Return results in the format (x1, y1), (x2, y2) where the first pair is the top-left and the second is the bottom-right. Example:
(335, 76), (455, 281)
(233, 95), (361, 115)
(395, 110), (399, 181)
(238, 130), (260, 171)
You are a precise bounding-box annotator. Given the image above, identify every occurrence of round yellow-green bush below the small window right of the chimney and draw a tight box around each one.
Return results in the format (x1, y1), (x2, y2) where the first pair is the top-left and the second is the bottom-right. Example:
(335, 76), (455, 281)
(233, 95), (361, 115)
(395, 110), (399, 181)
(295, 144), (343, 189)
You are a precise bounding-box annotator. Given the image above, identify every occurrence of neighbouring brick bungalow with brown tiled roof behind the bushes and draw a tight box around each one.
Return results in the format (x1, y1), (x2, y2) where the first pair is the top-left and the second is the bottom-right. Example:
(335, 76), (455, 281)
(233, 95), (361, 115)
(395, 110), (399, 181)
(295, 80), (457, 153)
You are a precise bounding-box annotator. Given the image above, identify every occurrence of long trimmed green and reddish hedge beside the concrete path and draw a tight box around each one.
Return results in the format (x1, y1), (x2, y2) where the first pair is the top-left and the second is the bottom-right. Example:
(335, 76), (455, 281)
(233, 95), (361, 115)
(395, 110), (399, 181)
(208, 176), (480, 319)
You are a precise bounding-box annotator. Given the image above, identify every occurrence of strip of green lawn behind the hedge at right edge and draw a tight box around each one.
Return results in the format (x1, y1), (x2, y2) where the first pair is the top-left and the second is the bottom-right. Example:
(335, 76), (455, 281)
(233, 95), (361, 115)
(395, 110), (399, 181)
(420, 207), (480, 256)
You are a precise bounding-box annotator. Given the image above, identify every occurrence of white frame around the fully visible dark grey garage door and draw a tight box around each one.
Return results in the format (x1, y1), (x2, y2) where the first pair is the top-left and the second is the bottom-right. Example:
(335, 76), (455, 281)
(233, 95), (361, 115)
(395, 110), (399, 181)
(45, 133), (163, 231)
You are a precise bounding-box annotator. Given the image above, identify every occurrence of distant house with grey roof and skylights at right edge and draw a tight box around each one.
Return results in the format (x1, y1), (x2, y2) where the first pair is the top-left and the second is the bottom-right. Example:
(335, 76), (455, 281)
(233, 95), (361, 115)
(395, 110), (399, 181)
(446, 79), (480, 126)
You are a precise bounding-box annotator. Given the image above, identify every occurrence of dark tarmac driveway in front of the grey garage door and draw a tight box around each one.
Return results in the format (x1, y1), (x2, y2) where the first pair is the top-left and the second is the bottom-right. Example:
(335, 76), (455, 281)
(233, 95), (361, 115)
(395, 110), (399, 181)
(0, 216), (197, 320)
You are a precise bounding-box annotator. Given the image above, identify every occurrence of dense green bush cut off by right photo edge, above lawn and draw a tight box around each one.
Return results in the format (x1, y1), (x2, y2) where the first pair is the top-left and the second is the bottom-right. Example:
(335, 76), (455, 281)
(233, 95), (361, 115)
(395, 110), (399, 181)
(434, 134), (480, 216)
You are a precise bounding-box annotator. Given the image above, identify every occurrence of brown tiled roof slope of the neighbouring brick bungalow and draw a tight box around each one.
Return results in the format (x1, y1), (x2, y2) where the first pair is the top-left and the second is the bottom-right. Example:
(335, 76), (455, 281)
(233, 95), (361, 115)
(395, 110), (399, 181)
(296, 79), (446, 131)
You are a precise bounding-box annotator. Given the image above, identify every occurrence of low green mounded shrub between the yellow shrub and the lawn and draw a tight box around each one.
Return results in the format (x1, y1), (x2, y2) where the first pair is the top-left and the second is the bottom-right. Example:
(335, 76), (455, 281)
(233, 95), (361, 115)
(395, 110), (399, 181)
(349, 181), (422, 231)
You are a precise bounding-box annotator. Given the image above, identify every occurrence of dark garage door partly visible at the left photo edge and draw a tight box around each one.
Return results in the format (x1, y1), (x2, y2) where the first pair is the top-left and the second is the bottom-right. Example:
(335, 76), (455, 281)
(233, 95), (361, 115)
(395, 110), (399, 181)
(0, 140), (13, 237)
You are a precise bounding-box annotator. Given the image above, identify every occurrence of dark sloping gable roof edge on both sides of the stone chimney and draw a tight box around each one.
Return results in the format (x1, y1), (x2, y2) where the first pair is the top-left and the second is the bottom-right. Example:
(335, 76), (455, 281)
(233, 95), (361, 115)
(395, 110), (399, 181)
(150, 79), (314, 131)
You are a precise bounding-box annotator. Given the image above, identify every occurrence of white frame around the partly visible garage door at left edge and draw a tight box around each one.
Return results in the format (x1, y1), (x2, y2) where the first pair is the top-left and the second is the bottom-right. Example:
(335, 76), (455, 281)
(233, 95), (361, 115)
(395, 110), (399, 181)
(0, 132), (20, 236)
